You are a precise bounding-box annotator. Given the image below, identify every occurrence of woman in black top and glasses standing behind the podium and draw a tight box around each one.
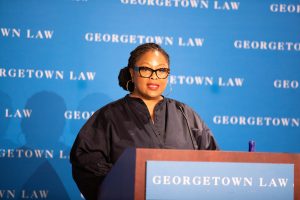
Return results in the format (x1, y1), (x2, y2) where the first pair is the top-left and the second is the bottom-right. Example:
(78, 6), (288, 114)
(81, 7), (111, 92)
(70, 43), (218, 199)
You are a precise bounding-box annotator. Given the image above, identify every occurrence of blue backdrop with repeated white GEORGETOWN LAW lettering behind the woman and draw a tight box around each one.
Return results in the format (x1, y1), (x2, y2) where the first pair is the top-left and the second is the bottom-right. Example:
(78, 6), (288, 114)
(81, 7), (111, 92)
(0, 0), (300, 199)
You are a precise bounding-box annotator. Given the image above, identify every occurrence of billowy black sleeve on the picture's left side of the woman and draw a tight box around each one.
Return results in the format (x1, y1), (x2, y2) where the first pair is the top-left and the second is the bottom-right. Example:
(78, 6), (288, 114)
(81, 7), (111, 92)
(70, 112), (112, 200)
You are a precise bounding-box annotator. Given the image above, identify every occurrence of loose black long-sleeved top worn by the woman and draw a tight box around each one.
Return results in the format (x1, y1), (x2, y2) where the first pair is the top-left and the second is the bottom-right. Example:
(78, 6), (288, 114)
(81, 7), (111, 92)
(70, 95), (218, 199)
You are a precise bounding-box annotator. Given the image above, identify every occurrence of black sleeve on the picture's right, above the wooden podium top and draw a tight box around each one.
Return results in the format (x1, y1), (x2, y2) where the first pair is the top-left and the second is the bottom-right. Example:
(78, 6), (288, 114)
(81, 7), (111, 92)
(184, 105), (220, 150)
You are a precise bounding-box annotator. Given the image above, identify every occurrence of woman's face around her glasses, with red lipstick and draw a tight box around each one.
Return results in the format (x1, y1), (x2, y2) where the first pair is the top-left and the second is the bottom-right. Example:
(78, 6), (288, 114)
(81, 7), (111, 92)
(130, 50), (169, 100)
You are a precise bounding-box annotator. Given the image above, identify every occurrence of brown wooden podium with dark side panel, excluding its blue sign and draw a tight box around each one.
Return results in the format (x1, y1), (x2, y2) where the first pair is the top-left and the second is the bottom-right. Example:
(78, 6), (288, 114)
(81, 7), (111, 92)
(98, 148), (300, 200)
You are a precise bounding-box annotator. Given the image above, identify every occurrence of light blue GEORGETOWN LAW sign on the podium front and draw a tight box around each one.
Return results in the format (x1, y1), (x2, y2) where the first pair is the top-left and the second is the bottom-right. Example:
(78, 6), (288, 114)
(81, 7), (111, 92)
(146, 161), (294, 200)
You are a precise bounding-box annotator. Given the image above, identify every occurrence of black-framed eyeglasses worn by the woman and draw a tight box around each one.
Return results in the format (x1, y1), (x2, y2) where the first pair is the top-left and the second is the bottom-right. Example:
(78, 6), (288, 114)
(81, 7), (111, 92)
(133, 66), (170, 79)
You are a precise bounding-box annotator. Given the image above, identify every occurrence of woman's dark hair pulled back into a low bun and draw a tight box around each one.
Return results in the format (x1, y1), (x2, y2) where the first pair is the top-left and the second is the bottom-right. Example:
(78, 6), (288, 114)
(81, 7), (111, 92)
(118, 43), (170, 92)
